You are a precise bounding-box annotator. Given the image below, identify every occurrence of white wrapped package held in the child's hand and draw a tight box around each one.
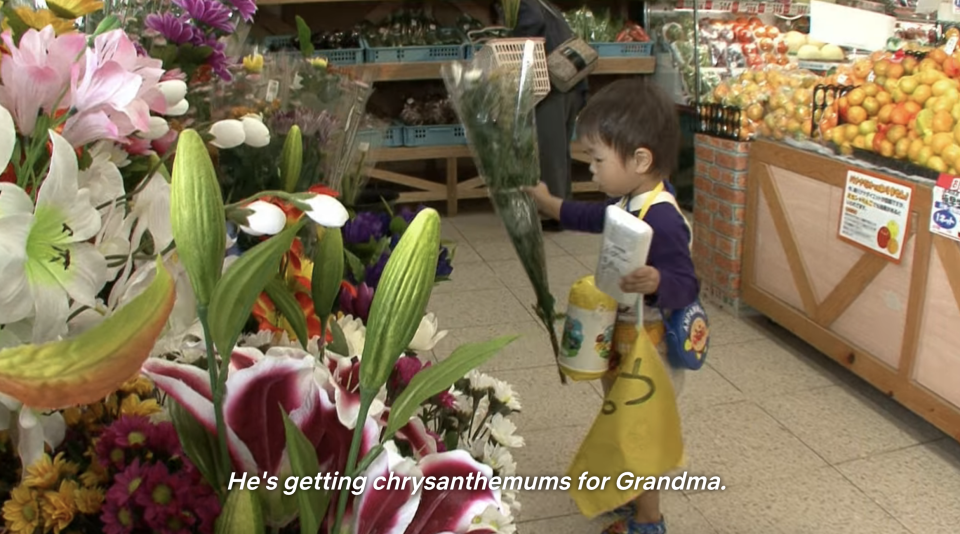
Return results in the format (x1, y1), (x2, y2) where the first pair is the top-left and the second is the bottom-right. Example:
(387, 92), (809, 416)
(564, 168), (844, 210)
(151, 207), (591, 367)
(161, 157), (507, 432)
(594, 205), (653, 306)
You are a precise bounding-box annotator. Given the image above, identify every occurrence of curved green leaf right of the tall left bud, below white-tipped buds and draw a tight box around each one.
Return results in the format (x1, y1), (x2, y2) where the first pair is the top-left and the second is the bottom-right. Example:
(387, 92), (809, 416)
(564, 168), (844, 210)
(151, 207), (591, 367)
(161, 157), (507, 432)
(209, 221), (306, 368)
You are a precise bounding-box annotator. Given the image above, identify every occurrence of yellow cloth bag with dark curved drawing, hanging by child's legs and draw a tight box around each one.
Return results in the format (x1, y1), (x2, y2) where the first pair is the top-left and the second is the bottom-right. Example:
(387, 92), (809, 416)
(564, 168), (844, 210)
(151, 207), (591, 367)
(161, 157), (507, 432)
(567, 322), (683, 519)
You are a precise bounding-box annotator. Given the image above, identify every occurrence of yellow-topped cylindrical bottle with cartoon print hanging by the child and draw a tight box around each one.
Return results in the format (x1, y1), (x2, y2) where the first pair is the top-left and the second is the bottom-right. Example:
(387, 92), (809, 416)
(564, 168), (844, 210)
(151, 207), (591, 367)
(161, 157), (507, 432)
(559, 275), (617, 381)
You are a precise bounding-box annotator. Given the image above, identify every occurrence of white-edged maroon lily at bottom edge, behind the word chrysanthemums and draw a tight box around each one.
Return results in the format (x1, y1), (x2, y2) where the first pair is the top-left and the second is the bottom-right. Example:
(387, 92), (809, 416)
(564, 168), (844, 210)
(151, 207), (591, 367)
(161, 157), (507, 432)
(351, 442), (502, 534)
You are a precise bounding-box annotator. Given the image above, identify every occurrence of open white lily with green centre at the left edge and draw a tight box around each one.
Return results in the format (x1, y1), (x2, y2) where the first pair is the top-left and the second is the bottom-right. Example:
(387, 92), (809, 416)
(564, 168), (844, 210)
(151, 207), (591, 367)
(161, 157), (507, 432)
(0, 131), (107, 343)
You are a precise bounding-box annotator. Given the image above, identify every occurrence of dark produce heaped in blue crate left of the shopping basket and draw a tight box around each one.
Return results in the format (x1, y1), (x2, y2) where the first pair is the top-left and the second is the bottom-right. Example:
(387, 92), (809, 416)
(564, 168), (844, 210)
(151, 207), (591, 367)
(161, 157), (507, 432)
(362, 8), (464, 48)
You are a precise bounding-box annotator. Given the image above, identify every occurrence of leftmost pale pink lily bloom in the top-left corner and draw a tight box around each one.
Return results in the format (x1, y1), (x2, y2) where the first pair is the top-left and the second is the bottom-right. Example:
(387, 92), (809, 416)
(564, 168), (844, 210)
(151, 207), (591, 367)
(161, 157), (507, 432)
(0, 26), (87, 136)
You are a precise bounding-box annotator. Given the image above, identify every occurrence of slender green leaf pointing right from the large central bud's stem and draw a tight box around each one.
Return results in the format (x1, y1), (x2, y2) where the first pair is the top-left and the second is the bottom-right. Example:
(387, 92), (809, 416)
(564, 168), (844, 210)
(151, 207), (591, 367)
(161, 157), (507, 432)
(383, 335), (519, 441)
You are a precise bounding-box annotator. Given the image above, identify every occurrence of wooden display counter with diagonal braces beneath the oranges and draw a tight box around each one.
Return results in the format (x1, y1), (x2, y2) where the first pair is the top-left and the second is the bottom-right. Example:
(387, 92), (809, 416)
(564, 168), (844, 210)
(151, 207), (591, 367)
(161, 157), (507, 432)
(742, 141), (960, 440)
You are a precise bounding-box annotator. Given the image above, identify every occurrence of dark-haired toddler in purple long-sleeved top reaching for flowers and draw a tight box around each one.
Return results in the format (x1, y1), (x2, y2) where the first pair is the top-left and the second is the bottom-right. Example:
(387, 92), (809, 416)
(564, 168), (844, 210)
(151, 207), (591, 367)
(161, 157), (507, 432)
(527, 78), (700, 534)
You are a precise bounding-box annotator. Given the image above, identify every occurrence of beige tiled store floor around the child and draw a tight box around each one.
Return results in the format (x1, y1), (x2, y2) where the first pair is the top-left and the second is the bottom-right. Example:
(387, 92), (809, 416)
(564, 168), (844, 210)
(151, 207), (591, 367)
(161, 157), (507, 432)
(430, 213), (960, 534)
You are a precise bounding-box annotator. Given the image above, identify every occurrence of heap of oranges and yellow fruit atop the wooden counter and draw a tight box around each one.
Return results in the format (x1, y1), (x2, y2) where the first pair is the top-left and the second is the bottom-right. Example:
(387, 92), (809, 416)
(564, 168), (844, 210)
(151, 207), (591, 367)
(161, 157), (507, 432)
(709, 43), (960, 176)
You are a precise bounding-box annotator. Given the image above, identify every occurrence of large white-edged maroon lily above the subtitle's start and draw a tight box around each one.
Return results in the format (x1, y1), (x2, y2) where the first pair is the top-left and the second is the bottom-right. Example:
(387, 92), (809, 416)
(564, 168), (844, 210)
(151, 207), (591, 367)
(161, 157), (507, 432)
(143, 348), (379, 526)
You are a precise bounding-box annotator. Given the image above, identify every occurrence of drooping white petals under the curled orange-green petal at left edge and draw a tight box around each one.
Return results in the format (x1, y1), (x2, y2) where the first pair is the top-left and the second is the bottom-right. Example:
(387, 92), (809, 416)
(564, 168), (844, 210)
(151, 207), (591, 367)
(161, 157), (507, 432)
(0, 393), (67, 472)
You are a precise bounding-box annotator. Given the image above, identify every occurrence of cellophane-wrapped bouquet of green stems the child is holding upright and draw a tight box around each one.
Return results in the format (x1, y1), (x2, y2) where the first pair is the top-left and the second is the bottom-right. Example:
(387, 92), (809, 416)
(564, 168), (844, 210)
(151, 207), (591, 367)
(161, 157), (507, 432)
(443, 41), (566, 383)
